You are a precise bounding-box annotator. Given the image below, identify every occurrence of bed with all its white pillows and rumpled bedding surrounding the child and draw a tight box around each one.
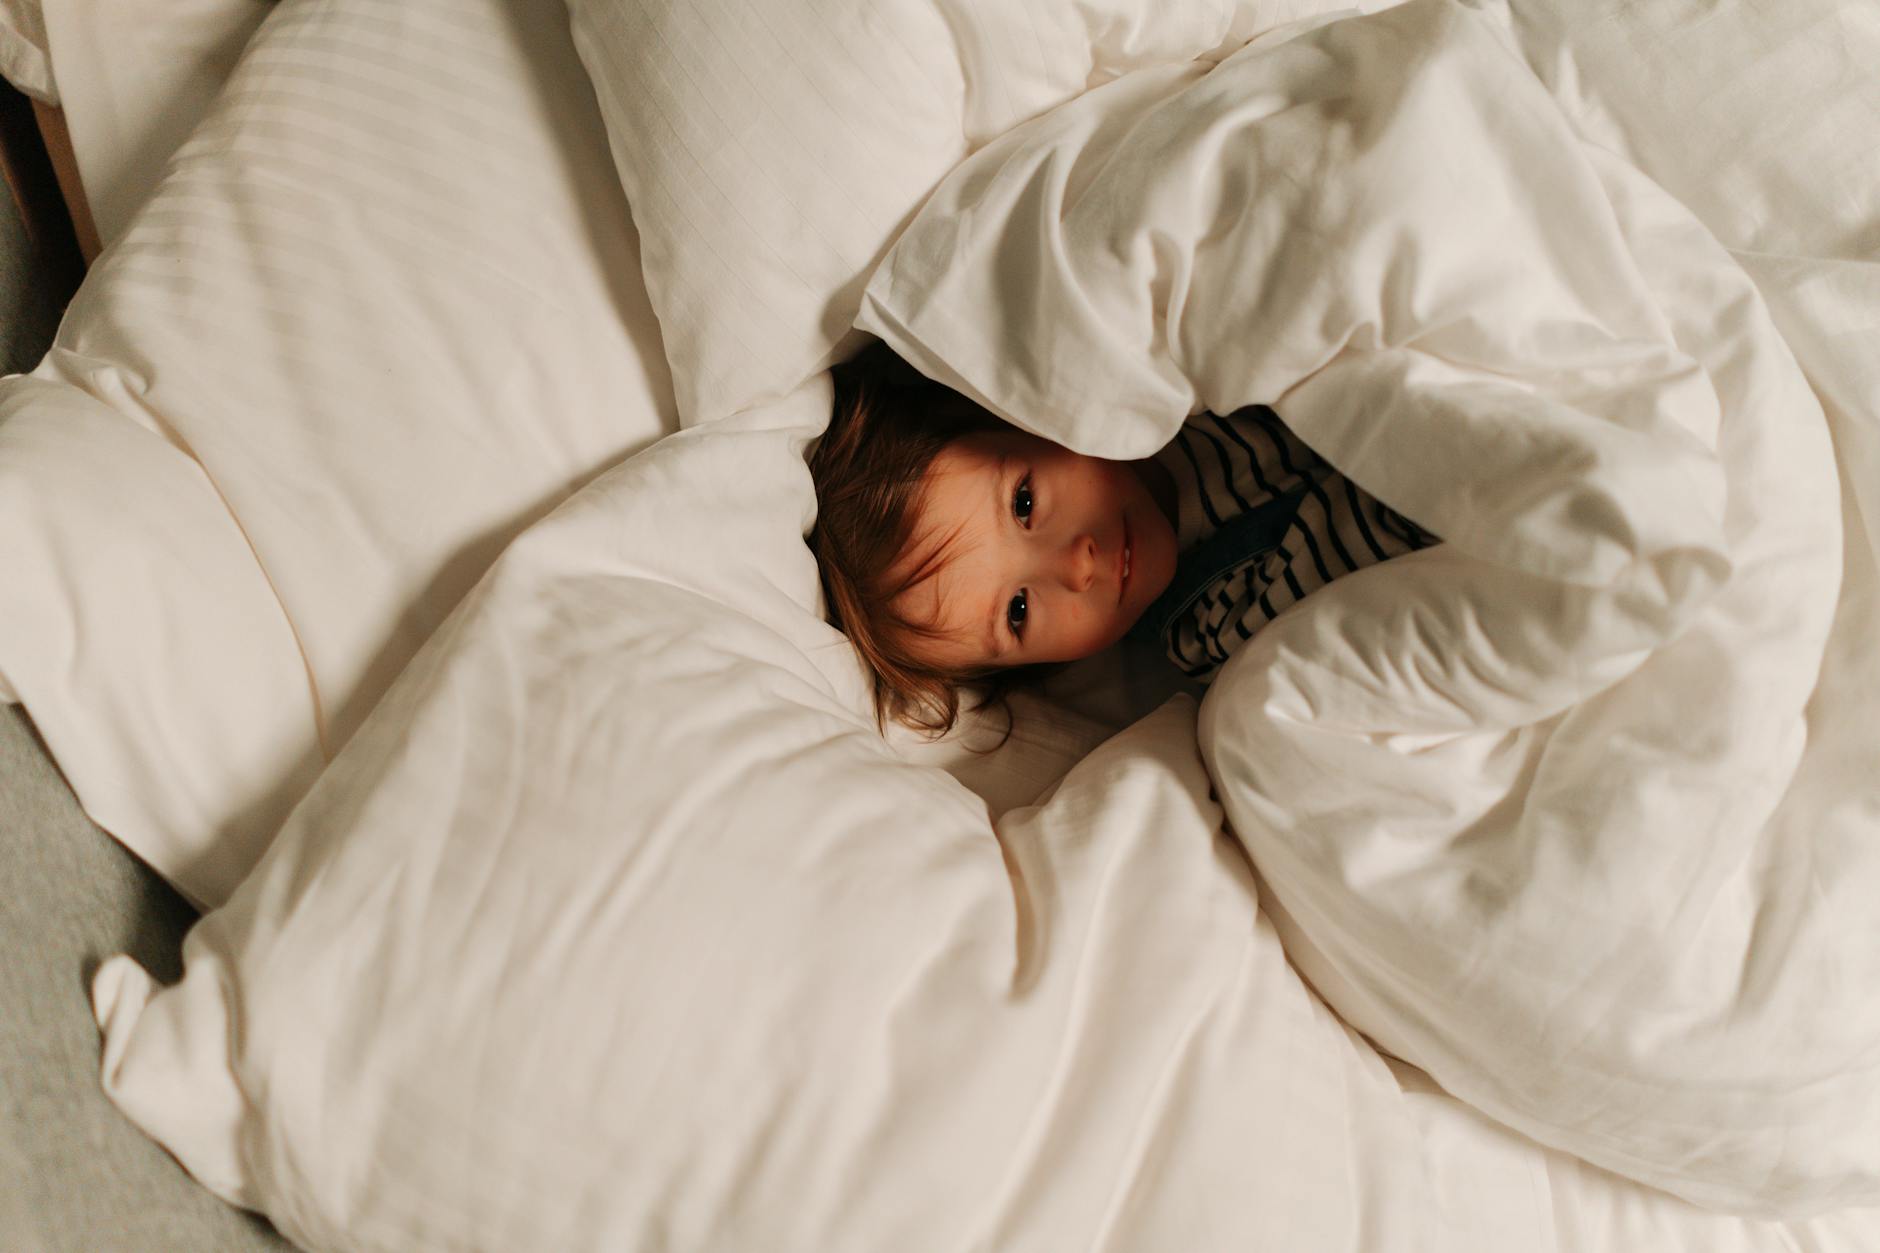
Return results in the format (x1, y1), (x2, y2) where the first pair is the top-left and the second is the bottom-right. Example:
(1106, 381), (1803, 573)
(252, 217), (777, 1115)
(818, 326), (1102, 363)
(0, 0), (1880, 1249)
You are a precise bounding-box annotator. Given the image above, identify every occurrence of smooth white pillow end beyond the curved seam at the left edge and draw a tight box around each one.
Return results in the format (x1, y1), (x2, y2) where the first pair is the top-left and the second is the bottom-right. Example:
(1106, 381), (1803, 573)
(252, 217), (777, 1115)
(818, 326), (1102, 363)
(0, 378), (320, 901)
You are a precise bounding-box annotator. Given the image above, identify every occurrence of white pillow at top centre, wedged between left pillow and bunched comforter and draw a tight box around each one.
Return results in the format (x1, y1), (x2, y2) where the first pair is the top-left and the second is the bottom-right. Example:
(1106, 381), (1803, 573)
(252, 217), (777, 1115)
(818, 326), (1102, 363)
(570, 0), (1376, 423)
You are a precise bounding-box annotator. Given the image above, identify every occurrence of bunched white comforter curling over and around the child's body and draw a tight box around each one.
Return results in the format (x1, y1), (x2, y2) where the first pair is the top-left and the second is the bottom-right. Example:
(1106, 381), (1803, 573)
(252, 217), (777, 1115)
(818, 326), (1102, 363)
(865, 0), (1880, 1212)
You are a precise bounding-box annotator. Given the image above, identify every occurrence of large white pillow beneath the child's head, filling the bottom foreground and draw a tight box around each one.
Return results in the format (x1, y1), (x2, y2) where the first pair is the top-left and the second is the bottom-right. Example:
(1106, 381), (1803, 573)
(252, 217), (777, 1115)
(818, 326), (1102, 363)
(96, 380), (1852, 1253)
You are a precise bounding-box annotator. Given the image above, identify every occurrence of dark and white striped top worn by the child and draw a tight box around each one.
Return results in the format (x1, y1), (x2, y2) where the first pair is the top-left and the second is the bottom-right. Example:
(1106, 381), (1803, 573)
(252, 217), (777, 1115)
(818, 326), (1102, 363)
(1156, 404), (1436, 681)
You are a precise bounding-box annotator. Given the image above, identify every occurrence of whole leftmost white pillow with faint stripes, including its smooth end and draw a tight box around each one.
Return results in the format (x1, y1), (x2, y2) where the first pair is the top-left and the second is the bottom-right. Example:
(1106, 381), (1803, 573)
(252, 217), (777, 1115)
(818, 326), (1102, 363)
(0, 0), (673, 903)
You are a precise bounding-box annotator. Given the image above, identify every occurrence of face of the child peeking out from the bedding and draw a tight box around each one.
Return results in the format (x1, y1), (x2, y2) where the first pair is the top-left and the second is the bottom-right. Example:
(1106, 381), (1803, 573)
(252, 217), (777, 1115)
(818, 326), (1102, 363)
(893, 431), (1175, 668)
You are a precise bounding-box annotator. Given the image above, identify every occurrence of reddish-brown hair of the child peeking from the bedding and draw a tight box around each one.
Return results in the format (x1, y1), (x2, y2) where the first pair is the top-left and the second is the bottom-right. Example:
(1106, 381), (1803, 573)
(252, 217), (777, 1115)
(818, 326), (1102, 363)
(808, 344), (1036, 736)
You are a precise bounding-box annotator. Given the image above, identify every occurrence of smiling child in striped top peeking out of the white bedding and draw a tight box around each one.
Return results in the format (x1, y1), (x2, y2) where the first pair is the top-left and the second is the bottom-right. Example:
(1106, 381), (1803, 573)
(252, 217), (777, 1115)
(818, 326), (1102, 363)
(808, 346), (1436, 734)
